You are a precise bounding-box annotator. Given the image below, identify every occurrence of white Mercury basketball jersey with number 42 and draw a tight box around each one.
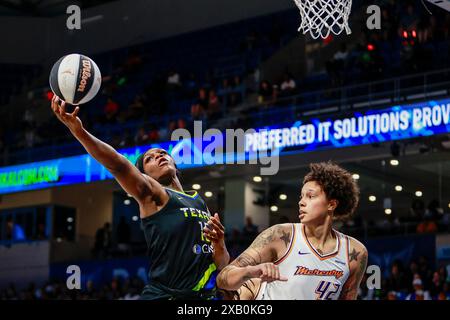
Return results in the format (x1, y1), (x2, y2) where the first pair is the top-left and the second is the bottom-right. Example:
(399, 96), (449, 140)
(256, 223), (350, 300)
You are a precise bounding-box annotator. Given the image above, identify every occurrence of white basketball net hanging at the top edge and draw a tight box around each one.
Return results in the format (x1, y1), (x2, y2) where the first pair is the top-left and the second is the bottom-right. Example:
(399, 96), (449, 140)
(294, 0), (352, 39)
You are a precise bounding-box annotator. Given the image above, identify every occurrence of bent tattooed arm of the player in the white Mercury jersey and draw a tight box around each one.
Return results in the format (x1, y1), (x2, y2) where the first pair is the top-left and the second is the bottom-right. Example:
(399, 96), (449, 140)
(217, 225), (287, 290)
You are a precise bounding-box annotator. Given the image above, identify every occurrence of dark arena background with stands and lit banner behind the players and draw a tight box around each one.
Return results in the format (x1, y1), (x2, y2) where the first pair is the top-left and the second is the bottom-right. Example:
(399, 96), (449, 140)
(0, 0), (450, 308)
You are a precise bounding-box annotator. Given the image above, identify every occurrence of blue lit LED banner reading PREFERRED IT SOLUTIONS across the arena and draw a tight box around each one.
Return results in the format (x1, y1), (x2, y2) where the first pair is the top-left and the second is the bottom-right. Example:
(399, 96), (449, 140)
(0, 99), (450, 194)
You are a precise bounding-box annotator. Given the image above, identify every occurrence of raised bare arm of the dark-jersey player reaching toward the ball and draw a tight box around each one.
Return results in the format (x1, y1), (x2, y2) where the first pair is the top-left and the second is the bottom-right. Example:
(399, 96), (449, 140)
(51, 96), (161, 201)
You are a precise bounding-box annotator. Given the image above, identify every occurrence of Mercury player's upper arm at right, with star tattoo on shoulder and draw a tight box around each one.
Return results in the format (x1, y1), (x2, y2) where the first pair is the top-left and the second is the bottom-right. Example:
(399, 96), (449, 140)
(339, 238), (368, 300)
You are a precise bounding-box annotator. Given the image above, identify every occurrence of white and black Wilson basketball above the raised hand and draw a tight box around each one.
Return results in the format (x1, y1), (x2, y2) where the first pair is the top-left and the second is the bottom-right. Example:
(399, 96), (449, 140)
(50, 53), (102, 105)
